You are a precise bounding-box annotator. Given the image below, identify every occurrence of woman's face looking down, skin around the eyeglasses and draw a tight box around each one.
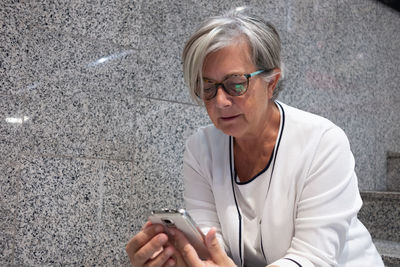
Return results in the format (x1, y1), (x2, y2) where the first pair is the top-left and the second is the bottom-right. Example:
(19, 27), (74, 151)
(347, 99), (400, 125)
(203, 41), (274, 139)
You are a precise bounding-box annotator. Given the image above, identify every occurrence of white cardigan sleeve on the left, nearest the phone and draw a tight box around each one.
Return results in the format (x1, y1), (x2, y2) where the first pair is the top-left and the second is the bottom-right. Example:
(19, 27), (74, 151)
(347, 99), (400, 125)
(183, 136), (228, 252)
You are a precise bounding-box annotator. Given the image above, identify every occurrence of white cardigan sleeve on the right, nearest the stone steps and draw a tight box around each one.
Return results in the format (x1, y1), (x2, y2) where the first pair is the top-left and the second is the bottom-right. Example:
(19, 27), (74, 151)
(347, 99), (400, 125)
(271, 126), (362, 266)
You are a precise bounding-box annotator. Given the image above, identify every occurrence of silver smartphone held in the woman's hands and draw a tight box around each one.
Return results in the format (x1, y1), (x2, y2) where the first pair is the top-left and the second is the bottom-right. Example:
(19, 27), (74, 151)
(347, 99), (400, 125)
(149, 209), (210, 260)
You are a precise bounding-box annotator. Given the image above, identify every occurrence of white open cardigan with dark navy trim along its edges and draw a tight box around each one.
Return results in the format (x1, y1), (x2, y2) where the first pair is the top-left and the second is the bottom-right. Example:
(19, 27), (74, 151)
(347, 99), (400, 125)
(183, 102), (383, 267)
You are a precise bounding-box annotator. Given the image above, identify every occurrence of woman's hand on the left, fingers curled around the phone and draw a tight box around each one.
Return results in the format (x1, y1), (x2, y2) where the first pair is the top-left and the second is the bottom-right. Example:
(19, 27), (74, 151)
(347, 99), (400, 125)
(125, 222), (176, 267)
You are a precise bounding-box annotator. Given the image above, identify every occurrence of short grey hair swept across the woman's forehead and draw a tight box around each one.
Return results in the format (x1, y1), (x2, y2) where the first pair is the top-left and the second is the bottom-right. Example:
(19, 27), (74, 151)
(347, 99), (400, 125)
(182, 7), (283, 101)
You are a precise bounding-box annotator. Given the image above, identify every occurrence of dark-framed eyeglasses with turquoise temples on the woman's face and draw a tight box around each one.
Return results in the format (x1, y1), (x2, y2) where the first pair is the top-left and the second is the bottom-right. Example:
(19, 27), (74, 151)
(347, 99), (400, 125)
(195, 70), (264, 100)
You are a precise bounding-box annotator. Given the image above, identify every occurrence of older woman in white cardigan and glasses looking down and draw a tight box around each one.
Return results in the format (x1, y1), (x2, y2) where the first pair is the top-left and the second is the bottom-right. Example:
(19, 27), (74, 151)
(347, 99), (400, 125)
(126, 8), (383, 267)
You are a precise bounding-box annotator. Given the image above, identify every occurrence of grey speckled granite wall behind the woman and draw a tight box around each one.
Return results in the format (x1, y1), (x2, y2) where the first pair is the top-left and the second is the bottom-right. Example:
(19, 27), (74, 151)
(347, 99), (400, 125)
(0, 0), (400, 266)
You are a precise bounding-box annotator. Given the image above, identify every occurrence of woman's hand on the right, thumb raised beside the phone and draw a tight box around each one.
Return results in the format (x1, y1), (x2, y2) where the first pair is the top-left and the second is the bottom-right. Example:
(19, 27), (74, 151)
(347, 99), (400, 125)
(170, 228), (236, 267)
